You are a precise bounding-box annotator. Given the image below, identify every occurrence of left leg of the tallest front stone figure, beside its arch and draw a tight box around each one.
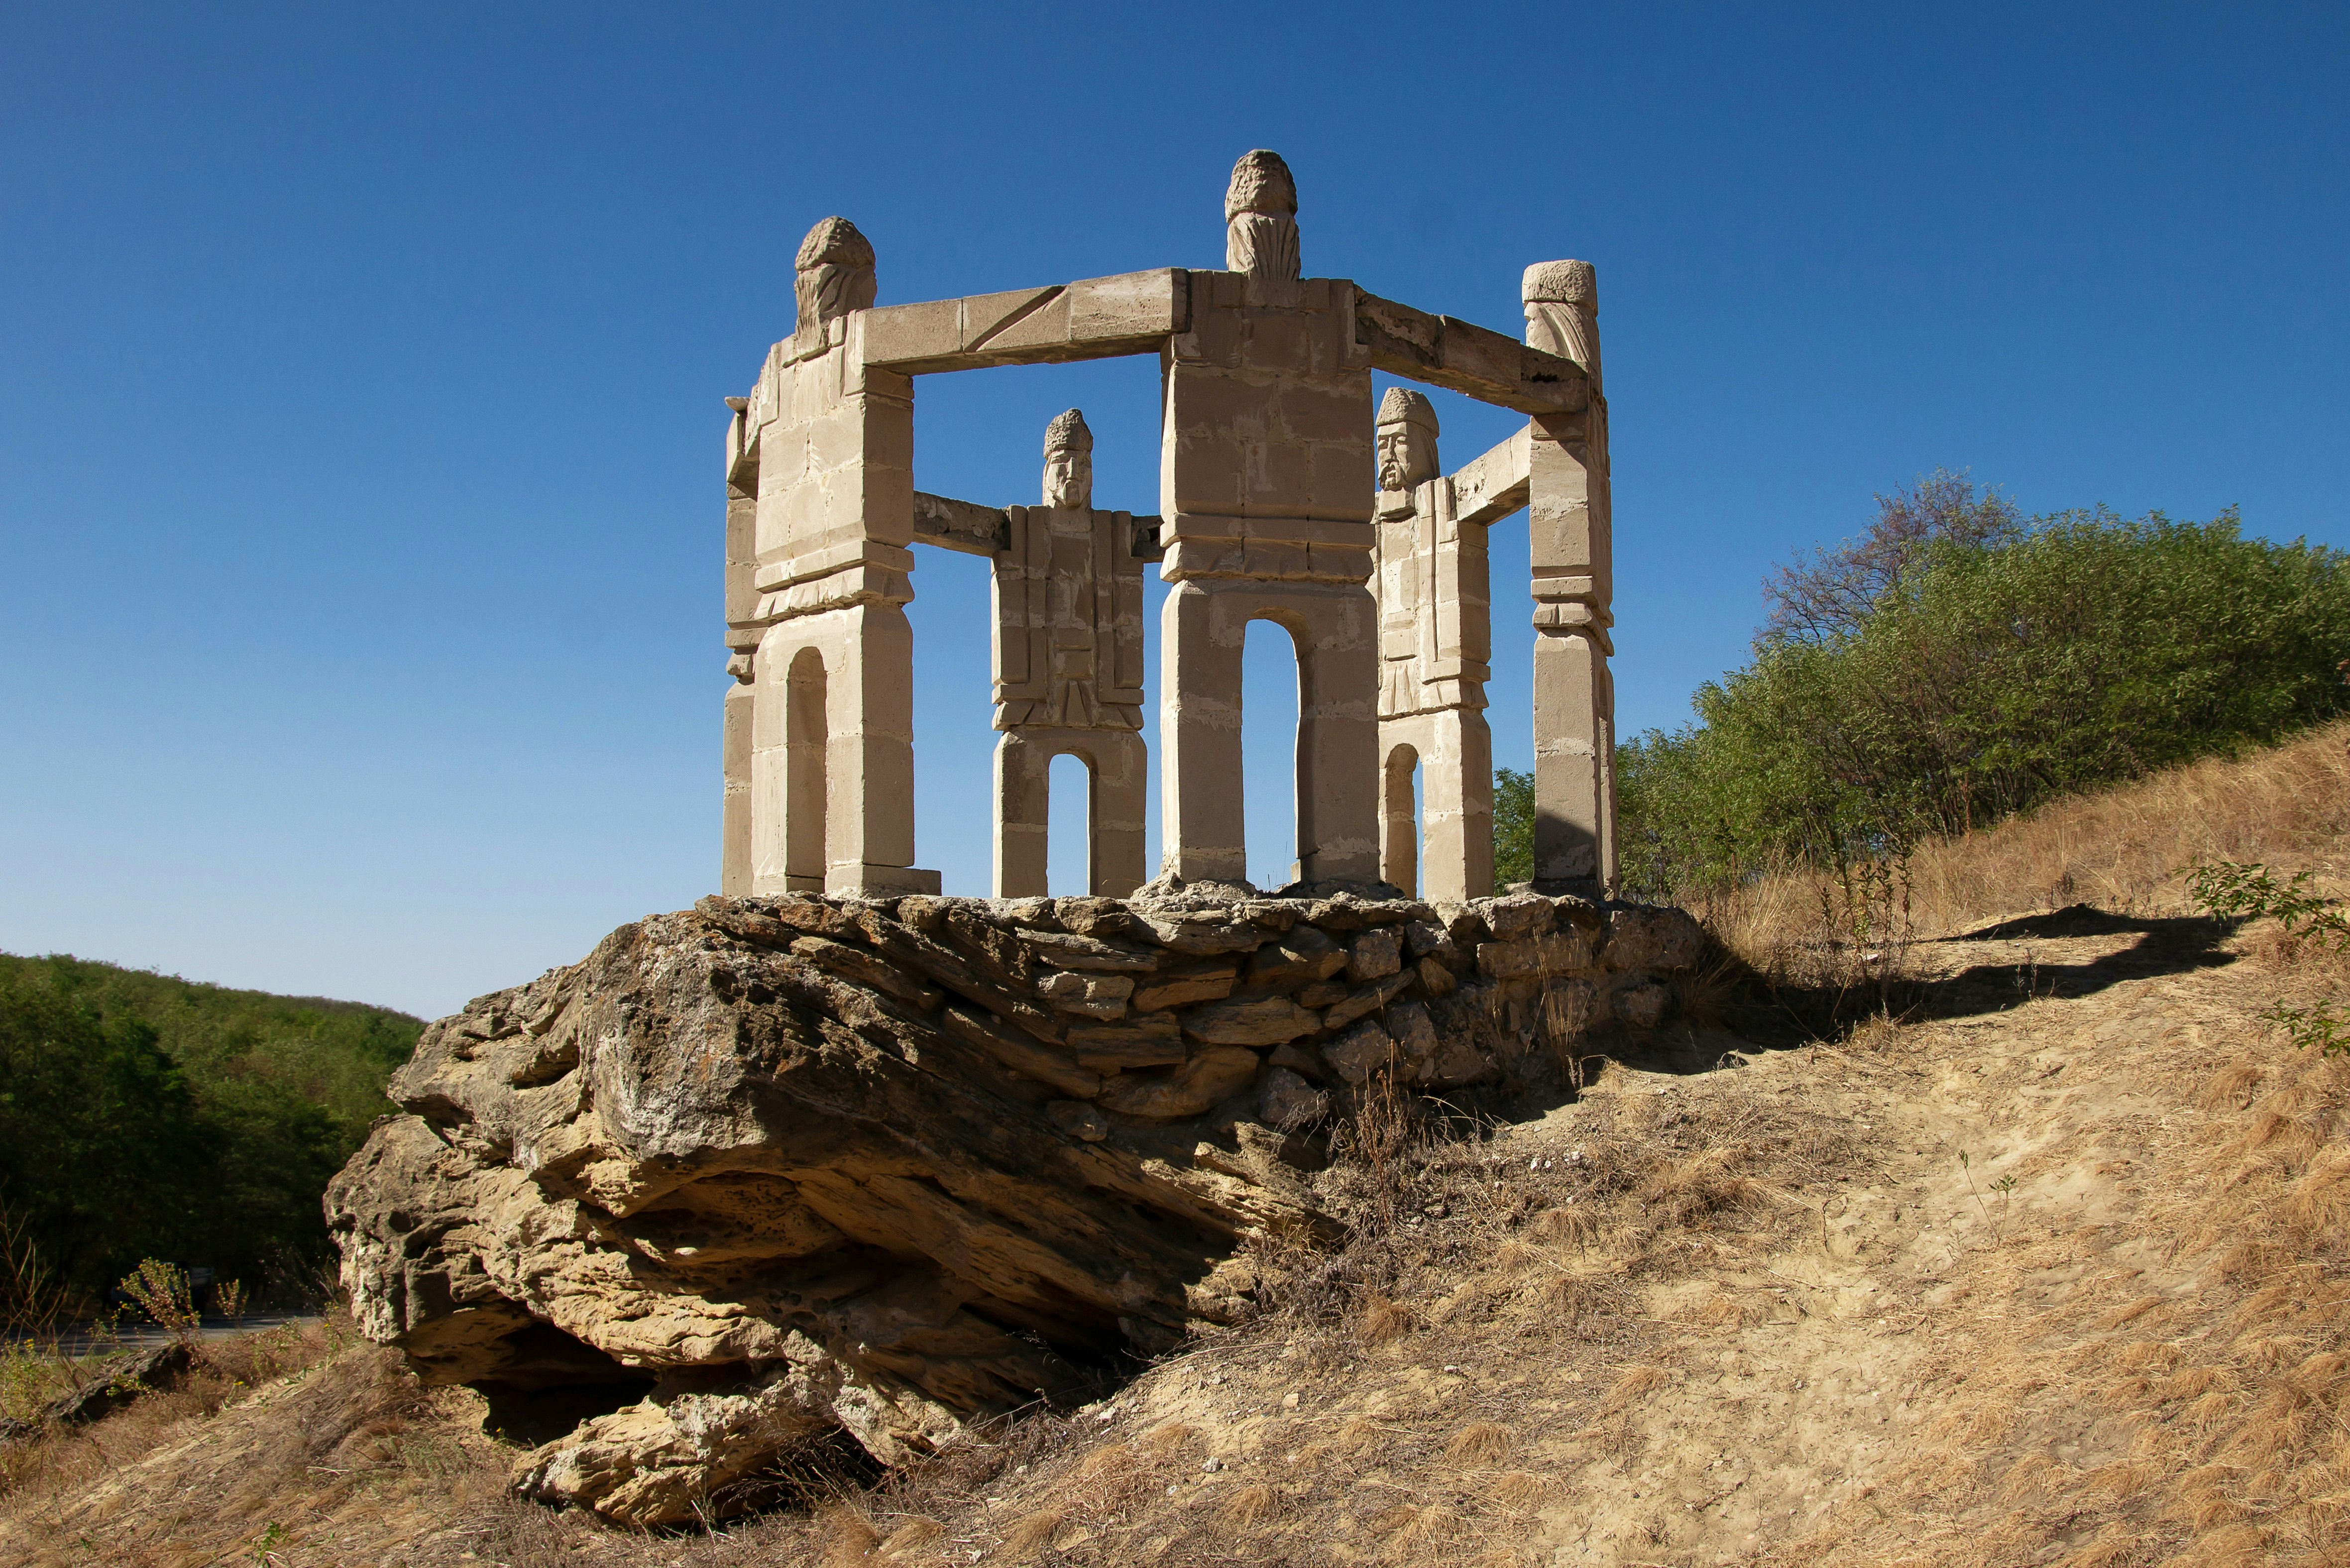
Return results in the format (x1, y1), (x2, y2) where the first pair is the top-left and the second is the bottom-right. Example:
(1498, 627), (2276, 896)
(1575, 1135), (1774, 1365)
(1158, 583), (1248, 882)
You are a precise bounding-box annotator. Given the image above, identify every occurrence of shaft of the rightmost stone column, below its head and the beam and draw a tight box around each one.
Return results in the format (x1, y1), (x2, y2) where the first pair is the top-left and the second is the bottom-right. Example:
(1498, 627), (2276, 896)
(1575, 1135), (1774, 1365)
(1528, 416), (1614, 894)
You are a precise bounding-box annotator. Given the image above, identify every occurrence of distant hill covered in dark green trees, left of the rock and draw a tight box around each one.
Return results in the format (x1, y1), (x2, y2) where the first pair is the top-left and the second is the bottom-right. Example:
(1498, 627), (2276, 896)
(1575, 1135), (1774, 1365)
(0, 954), (423, 1291)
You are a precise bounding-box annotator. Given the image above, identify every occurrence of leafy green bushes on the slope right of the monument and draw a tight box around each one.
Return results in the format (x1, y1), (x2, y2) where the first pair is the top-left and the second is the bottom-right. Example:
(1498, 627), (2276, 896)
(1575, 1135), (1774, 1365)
(1617, 475), (2350, 896)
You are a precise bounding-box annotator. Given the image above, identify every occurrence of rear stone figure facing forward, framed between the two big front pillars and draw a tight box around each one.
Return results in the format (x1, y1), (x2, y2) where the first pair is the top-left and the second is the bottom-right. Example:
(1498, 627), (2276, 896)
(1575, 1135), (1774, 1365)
(994, 409), (1147, 898)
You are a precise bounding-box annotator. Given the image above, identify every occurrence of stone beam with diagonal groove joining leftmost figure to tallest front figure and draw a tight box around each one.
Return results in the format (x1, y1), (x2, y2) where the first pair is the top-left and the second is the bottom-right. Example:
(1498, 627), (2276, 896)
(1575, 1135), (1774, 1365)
(848, 268), (1192, 376)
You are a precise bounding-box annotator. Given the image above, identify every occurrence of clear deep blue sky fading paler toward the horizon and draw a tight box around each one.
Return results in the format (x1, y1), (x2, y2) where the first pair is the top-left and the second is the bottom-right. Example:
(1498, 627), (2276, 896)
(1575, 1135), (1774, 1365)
(0, 0), (2350, 1013)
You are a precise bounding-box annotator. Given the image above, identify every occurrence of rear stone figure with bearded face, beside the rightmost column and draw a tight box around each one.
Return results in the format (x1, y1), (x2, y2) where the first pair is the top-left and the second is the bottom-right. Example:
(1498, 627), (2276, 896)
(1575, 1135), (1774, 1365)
(1377, 386), (1492, 900)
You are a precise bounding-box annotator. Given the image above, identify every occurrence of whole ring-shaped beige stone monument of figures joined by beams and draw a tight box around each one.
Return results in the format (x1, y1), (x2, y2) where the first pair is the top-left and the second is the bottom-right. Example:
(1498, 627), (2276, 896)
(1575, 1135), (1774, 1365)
(721, 150), (1614, 898)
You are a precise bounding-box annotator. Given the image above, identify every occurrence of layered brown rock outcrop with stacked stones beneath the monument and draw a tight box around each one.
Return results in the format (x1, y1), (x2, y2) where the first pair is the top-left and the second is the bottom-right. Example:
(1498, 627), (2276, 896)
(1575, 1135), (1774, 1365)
(327, 884), (1701, 1526)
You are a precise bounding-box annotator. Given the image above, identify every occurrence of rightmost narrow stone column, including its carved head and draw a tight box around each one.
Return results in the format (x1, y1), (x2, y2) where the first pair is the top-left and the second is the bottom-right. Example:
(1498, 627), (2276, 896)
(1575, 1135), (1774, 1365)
(1523, 261), (1617, 891)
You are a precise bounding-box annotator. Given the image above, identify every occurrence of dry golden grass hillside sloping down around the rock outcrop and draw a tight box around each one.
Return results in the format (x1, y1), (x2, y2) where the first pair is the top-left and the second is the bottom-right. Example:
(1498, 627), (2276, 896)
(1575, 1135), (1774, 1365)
(0, 729), (2350, 1568)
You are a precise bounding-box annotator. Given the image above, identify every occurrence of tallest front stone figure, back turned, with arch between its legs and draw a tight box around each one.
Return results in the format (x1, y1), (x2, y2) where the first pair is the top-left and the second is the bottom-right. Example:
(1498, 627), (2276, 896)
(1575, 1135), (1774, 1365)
(1158, 150), (1379, 882)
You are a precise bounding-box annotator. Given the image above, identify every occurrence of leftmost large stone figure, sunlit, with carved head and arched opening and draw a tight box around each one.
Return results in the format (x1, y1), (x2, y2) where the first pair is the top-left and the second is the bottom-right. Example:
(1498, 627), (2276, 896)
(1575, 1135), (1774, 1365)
(721, 219), (938, 894)
